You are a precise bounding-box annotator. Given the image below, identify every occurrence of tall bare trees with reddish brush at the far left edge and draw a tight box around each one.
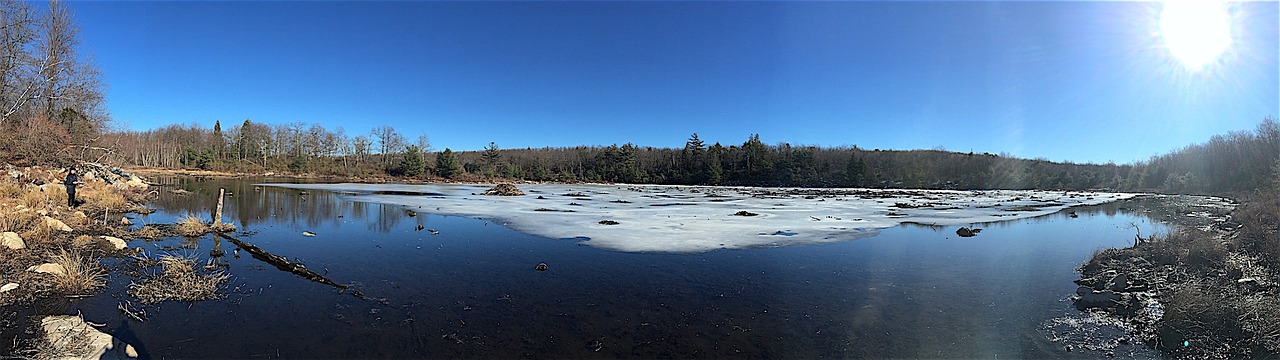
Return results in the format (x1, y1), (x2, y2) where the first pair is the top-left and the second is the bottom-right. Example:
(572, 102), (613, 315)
(0, 0), (109, 163)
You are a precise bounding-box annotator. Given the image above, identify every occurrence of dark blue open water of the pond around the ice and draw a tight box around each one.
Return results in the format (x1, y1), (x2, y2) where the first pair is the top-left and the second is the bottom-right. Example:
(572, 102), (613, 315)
(12, 179), (1164, 359)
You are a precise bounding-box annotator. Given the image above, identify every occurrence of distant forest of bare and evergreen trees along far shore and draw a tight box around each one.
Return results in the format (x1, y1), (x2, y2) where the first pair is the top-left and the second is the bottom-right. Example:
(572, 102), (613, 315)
(60, 118), (1280, 193)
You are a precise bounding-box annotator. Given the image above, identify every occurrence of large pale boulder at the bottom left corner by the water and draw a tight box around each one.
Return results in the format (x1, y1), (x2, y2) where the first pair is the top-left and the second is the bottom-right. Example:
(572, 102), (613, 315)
(40, 315), (128, 359)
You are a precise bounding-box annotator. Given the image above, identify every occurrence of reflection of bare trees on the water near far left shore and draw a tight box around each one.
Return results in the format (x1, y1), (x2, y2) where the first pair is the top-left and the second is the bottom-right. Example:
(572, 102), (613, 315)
(143, 177), (406, 232)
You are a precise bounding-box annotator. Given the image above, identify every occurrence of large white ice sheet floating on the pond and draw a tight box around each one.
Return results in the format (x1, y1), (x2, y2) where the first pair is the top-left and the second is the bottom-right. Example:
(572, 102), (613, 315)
(264, 183), (1137, 252)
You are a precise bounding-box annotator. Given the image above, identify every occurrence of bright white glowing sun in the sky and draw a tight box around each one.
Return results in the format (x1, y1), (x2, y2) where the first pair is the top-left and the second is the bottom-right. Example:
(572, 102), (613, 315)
(1160, 0), (1231, 72)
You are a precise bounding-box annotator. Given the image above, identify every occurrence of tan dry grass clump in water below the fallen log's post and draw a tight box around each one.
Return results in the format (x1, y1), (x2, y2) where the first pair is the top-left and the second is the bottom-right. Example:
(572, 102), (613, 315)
(129, 255), (229, 304)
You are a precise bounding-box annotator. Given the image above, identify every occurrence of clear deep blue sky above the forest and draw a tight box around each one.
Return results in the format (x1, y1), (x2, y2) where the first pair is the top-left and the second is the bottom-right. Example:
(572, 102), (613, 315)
(69, 1), (1280, 163)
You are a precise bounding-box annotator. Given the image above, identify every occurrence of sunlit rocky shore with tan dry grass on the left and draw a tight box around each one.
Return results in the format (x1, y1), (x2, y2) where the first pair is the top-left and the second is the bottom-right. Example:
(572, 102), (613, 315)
(0, 163), (167, 359)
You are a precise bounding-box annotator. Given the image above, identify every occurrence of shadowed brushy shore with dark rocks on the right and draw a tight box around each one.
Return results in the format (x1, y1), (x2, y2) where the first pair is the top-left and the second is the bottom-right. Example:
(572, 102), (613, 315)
(1073, 196), (1280, 359)
